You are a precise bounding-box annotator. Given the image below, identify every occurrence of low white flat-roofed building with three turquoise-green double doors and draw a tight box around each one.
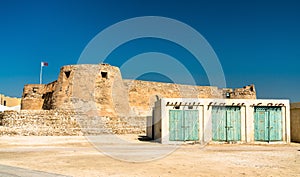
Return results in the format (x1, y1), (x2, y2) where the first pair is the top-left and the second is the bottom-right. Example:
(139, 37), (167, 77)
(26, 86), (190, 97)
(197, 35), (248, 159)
(147, 98), (290, 144)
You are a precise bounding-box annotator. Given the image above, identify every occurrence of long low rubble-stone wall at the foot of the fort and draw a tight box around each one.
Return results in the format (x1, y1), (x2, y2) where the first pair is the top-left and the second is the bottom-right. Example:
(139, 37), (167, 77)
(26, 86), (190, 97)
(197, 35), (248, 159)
(0, 110), (146, 136)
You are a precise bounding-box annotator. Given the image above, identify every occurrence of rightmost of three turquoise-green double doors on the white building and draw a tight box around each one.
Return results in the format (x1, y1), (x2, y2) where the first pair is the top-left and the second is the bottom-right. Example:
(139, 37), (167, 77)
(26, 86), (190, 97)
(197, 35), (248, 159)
(254, 107), (282, 141)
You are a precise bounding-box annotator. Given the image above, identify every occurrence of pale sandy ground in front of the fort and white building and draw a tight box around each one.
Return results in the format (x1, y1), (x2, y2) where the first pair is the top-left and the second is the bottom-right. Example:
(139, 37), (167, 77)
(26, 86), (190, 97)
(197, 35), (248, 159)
(0, 135), (300, 176)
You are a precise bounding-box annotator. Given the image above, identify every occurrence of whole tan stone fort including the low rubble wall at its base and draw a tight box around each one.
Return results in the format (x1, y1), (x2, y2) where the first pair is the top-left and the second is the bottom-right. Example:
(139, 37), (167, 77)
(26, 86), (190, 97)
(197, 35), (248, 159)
(0, 64), (256, 135)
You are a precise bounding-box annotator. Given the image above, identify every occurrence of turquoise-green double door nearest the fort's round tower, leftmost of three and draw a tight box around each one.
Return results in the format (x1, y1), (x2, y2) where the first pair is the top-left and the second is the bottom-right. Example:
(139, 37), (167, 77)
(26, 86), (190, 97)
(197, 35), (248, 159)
(169, 110), (199, 141)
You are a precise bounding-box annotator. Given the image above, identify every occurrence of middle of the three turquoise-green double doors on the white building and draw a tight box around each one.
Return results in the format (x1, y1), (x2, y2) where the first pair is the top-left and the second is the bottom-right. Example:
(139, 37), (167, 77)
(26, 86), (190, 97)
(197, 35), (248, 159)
(212, 106), (241, 141)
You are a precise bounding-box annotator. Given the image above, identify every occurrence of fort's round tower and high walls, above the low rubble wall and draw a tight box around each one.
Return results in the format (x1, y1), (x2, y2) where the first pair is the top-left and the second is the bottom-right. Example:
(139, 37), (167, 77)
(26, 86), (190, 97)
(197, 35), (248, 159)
(21, 64), (256, 117)
